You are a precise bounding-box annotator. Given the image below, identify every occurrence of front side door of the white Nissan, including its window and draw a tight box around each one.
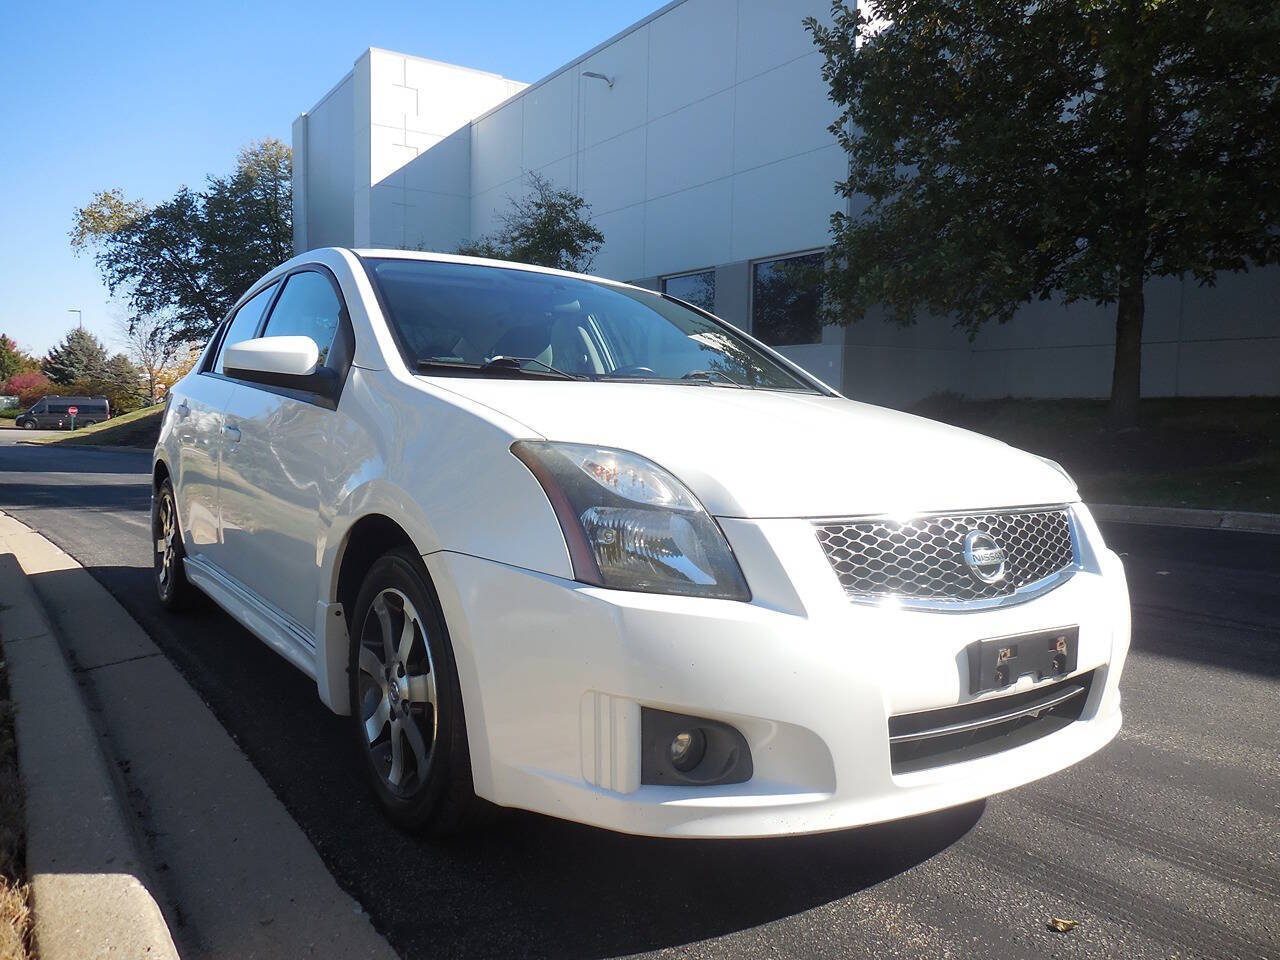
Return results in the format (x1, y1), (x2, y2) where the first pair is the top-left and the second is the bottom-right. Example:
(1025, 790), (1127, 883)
(220, 266), (355, 636)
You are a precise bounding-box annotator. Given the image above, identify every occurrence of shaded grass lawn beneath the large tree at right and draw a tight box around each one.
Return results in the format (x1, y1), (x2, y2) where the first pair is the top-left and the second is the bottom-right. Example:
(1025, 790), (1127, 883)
(911, 397), (1280, 513)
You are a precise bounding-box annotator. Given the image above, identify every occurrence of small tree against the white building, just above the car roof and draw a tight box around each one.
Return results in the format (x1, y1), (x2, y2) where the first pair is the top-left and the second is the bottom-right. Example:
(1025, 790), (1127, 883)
(457, 173), (604, 273)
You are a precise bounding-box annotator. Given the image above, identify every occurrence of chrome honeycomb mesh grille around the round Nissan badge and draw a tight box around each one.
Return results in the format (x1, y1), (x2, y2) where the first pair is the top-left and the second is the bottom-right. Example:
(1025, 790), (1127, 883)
(814, 507), (1075, 605)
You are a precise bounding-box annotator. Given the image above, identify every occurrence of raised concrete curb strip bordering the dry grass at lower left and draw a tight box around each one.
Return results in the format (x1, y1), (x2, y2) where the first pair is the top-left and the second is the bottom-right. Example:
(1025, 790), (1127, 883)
(0, 515), (178, 960)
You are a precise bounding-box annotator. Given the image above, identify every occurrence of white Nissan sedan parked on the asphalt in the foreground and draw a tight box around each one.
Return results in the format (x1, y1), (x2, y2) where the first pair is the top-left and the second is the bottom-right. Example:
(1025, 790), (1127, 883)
(152, 250), (1129, 837)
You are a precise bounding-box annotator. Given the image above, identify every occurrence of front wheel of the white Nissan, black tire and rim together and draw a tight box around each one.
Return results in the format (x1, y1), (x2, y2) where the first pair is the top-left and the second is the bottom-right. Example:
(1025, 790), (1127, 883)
(347, 549), (488, 837)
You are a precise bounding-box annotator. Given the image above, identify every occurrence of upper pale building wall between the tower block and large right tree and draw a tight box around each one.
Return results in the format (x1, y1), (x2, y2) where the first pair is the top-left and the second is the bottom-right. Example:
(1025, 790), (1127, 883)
(471, 0), (845, 288)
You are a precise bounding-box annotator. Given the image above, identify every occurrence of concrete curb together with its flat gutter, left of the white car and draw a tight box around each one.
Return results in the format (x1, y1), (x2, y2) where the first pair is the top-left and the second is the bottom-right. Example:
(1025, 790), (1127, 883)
(0, 515), (394, 960)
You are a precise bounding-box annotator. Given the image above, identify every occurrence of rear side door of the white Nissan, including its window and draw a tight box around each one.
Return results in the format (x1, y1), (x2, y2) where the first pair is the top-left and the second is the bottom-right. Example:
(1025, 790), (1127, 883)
(170, 284), (279, 566)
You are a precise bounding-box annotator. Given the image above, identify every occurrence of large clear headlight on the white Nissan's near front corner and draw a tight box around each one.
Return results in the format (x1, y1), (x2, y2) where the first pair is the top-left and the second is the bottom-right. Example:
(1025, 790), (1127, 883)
(511, 440), (751, 600)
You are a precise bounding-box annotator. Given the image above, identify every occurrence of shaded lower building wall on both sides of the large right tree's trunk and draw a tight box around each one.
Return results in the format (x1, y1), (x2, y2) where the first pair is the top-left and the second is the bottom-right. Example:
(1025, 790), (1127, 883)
(844, 268), (1280, 406)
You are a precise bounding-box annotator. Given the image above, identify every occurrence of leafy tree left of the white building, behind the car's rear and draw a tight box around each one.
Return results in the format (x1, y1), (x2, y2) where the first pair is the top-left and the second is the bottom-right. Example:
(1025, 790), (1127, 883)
(70, 140), (293, 340)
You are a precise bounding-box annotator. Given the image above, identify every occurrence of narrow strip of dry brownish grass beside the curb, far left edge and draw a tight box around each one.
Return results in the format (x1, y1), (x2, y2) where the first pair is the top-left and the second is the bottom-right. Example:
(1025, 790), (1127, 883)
(0, 663), (31, 960)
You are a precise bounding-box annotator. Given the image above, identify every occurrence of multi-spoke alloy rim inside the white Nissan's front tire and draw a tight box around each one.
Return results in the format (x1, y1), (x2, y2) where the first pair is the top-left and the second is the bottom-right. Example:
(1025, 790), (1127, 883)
(357, 588), (436, 796)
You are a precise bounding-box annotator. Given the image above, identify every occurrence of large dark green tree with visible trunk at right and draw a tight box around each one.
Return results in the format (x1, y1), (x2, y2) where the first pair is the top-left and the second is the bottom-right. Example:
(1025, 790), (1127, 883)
(805, 0), (1280, 426)
